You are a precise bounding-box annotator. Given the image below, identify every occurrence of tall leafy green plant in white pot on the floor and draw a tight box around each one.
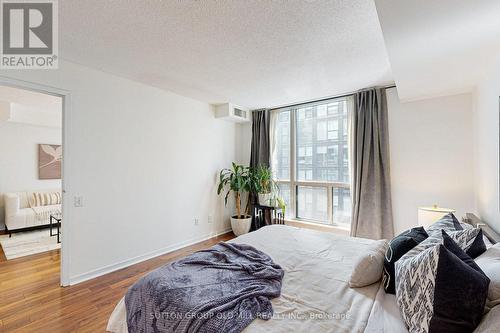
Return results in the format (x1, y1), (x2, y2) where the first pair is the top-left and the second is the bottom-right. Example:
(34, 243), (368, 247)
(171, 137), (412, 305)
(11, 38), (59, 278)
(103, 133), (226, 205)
(217, 162), (252, 236)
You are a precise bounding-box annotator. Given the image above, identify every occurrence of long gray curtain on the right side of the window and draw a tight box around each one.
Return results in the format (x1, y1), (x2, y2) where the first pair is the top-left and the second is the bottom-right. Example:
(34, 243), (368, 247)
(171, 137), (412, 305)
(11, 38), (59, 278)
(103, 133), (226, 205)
(351, 88), (394, 239)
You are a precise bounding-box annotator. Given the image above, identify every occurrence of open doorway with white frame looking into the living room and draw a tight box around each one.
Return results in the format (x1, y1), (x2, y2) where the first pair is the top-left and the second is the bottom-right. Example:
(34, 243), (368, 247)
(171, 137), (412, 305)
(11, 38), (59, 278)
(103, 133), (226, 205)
(0, 77), (70, 286)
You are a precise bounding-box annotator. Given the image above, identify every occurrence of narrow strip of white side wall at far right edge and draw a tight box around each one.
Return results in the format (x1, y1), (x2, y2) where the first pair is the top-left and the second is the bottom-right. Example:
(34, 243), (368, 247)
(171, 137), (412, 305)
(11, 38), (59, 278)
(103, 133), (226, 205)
(474, 62), (500, 232)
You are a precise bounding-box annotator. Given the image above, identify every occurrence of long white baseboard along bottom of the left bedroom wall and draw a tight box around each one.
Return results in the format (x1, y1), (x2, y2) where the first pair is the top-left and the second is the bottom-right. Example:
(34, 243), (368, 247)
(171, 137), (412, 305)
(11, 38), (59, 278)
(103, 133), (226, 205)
(69, 228), (231, 285)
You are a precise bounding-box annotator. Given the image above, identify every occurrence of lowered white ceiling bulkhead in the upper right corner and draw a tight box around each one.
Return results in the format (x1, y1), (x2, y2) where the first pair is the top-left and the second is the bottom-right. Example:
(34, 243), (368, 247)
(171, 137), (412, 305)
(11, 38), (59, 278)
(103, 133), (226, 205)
(375, 0), (500, 100)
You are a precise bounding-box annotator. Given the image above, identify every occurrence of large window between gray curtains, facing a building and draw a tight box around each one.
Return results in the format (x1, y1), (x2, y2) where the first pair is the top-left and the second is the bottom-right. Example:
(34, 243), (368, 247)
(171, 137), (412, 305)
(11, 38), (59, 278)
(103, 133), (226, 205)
(272, 98), (351, 226)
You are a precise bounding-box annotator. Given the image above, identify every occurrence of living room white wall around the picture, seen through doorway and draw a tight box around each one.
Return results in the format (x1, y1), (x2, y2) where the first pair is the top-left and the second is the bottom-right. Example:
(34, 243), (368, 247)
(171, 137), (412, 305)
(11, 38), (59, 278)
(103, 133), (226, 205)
(0, 122), (61, 229)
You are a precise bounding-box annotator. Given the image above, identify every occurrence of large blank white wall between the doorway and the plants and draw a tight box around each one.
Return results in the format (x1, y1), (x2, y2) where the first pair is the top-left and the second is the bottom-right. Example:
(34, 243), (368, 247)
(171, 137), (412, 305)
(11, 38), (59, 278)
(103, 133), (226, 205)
(0, 62), (236, 282)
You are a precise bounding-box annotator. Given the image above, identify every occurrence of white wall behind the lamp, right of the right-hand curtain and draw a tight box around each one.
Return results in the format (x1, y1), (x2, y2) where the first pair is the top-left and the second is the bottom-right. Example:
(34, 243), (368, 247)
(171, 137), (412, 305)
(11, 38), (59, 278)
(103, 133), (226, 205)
(387, 89), (475, 234)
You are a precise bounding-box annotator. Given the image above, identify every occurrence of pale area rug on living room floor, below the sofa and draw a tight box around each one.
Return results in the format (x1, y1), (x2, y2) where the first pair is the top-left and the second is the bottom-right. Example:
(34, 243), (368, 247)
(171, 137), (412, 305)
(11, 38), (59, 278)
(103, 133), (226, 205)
(0, 228), (61, 260)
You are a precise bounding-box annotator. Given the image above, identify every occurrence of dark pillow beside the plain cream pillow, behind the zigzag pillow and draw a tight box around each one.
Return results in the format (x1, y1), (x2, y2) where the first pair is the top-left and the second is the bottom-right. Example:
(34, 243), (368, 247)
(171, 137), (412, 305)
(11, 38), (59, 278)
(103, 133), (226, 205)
(382, 227), (429, 294)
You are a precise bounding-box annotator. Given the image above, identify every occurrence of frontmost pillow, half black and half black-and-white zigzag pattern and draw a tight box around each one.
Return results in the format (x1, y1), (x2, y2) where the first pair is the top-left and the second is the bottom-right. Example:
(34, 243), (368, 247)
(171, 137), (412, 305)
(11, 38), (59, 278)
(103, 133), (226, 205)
(396, 233), (490, 333)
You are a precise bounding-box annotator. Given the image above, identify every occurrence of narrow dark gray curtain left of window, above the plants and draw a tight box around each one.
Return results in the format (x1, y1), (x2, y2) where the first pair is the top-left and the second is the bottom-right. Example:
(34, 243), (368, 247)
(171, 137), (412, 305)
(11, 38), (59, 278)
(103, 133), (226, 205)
(250, 110), (271, 167)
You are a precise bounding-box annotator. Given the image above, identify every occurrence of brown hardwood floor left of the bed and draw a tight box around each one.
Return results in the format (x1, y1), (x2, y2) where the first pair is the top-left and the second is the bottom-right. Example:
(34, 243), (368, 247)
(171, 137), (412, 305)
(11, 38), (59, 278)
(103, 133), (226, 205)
(0, 233), (234, 333)
